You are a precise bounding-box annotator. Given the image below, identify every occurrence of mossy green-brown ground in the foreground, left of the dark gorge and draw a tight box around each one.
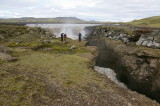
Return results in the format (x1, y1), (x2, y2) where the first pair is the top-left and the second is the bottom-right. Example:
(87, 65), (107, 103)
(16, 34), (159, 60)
(0, 25), (159, 106)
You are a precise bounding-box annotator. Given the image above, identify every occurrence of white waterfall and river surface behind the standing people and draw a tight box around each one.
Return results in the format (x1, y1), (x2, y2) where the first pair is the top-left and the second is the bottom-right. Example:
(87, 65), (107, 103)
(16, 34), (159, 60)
(27, 24), (100, 39)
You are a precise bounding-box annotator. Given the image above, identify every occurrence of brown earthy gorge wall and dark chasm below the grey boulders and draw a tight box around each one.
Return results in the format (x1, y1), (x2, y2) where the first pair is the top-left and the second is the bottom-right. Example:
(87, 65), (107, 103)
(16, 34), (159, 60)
(85, 25), (160, 102)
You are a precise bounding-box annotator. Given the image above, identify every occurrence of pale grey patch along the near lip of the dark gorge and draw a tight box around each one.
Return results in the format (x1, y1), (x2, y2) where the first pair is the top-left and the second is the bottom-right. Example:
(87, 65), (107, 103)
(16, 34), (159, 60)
(94, 66), (127, 88)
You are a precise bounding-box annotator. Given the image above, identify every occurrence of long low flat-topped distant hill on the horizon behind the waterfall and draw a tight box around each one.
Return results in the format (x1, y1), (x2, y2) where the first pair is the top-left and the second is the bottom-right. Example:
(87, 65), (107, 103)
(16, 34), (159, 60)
(0, 17), (100, 23)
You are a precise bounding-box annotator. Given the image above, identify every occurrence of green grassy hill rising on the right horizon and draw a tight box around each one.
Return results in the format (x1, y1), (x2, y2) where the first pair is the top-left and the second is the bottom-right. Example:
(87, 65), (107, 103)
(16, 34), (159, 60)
(127, 16), (160, 27)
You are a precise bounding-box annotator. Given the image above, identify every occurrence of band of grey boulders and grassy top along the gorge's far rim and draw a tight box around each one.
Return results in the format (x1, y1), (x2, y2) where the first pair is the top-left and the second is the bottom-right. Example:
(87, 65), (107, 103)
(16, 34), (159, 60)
(85, 26), (160, 49)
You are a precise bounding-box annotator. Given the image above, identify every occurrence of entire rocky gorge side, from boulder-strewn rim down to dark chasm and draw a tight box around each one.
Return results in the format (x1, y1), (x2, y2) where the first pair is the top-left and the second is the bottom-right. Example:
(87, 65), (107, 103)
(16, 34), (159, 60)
(85, 26), (160, 102)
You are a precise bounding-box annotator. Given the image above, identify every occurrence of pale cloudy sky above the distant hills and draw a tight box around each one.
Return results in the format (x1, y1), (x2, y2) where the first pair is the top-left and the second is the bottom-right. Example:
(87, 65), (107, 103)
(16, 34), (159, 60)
(0, 0), (160, 22)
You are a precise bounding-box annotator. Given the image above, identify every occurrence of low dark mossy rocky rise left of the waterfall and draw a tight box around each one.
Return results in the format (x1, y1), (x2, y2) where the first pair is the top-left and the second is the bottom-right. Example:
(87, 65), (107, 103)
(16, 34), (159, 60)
(0, 25), (55, 41)
